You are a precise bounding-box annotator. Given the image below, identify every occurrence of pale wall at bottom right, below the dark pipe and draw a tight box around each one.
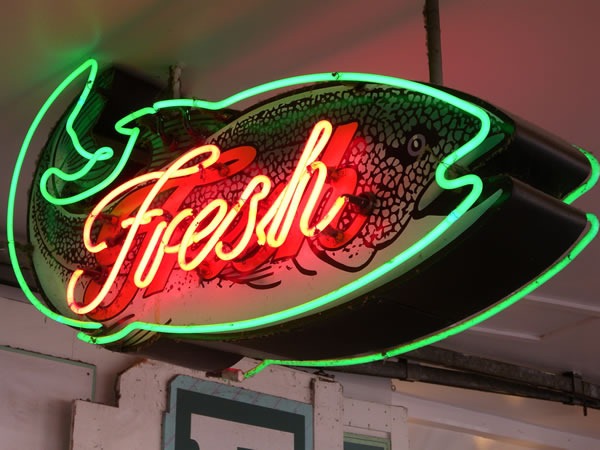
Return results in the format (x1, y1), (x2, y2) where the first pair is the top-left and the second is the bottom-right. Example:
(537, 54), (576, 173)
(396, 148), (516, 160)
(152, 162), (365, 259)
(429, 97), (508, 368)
(336, 373), (600, 450)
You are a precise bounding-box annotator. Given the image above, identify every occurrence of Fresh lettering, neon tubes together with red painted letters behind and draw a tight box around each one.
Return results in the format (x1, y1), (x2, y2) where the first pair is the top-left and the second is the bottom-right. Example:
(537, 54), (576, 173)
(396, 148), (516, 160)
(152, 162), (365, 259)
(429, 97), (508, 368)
(67, 120), (364, 320)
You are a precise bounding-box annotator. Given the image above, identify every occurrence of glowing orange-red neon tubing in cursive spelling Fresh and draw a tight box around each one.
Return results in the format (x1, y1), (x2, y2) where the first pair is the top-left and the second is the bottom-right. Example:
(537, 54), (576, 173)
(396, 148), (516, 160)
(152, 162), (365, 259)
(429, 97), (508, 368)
(67, 120), (360, 314)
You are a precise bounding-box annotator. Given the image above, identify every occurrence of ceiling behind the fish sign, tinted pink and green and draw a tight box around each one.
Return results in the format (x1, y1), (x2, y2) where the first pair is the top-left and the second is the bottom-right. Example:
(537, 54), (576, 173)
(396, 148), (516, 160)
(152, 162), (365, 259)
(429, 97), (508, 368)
(0, 0), (600, 436)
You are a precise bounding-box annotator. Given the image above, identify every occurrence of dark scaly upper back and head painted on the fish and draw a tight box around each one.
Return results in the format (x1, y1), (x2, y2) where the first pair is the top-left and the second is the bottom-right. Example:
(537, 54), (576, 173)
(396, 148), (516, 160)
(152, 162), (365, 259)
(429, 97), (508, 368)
(198, 85), (478, 270)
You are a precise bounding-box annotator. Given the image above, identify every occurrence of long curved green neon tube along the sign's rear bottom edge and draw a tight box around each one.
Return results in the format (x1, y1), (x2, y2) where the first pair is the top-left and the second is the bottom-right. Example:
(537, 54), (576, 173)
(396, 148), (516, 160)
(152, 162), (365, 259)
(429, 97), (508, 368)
(244, 214), (599, 378)
